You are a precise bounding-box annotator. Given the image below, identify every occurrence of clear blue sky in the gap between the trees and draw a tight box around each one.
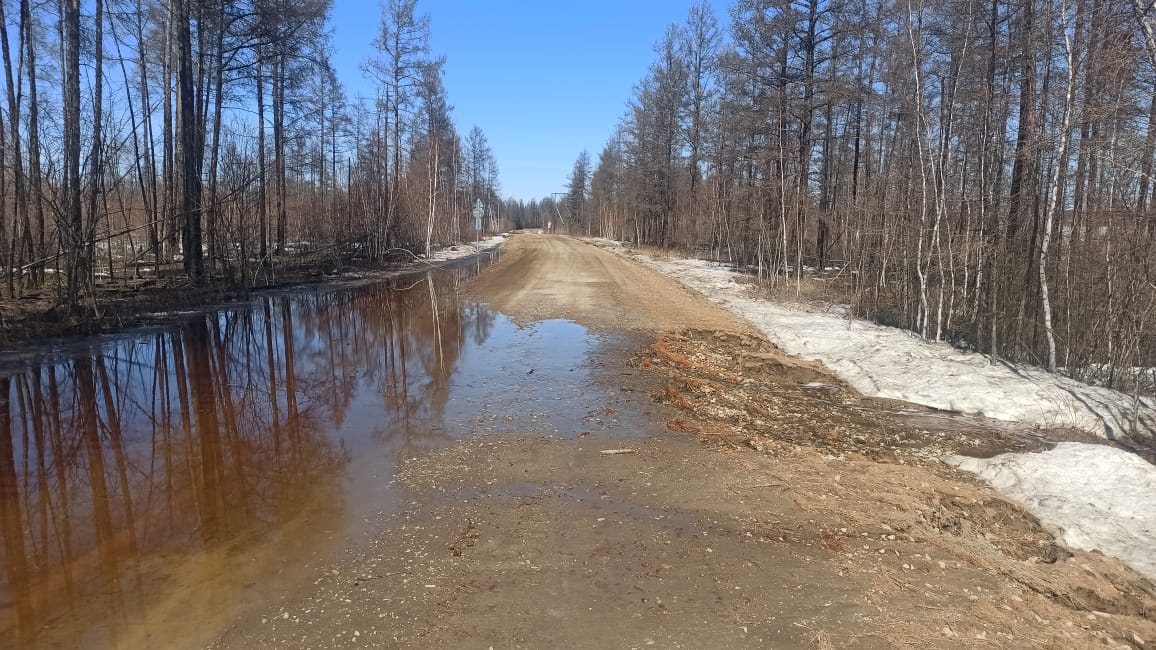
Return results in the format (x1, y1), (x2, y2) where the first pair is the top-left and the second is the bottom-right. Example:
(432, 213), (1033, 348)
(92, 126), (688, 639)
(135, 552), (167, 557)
(333, 0), (728, 200)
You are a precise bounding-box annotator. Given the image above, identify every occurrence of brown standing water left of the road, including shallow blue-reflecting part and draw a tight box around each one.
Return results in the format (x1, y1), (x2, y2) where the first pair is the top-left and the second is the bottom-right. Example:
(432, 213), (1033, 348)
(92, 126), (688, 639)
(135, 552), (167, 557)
(0, 255), (637, 648)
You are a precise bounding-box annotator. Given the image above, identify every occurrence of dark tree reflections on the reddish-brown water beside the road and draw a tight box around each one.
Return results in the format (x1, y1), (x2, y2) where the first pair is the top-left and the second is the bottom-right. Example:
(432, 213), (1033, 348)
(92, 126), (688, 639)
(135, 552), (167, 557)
(0, 261), (495, 645)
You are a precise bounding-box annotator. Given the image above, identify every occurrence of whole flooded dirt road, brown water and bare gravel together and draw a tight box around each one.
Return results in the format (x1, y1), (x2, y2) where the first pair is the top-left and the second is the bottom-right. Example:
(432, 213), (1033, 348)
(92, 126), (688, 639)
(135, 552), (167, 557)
(0, 230), (1156, 650)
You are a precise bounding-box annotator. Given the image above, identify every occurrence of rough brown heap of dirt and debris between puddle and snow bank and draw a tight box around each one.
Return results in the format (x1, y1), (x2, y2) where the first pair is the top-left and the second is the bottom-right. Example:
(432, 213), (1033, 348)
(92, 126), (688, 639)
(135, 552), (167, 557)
(637, 330), (1031, 463)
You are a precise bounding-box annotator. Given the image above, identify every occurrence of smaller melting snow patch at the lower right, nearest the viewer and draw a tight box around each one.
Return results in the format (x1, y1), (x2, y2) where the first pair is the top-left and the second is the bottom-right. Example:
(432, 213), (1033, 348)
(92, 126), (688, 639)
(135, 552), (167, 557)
(944, 442), (1156, 581)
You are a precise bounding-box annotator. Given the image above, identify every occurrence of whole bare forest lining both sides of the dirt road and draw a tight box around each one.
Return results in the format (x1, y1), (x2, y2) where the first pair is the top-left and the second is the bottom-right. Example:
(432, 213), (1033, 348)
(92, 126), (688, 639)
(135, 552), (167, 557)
(0, 0), (1156, 387)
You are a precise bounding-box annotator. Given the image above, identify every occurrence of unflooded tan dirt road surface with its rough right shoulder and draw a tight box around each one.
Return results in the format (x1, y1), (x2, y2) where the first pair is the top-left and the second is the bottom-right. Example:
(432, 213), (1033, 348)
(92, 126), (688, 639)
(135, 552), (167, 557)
(217, 235), (1156, 649)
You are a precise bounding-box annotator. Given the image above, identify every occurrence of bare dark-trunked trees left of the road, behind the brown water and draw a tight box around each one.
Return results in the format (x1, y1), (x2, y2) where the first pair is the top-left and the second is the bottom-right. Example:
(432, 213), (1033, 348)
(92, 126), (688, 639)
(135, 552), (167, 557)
(0, 0), (498, 313)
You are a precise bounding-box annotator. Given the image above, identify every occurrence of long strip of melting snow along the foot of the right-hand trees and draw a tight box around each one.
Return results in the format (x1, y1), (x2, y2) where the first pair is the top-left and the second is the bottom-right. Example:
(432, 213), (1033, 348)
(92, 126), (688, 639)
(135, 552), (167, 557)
(596, 239), (1156, 440)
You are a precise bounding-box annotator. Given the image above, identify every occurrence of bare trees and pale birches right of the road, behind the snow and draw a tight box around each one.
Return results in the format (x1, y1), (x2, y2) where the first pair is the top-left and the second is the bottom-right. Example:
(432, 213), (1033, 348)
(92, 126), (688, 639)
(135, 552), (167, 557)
(564, 0), (1156, 385)
